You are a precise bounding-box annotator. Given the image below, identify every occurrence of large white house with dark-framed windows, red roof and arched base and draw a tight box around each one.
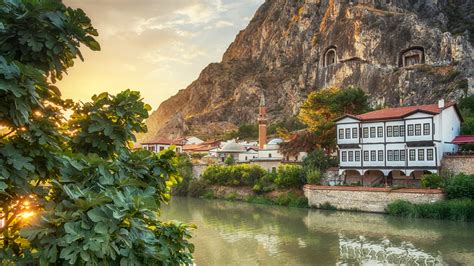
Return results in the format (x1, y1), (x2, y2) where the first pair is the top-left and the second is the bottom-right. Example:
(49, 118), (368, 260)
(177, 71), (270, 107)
(336, 101), (462, 185)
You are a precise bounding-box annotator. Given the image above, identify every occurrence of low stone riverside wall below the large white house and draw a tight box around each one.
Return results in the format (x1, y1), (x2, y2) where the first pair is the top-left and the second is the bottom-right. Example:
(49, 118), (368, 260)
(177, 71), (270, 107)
(304, 185), (444, 213)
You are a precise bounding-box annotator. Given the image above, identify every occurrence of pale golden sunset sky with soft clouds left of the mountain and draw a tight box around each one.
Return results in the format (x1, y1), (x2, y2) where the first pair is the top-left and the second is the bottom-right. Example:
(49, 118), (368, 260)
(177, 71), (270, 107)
(58, 0), (264, 109)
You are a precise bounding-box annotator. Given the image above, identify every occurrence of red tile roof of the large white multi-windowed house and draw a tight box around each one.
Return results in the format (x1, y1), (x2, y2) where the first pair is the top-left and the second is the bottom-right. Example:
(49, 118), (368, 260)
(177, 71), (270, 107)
(338, 103), (462, 121)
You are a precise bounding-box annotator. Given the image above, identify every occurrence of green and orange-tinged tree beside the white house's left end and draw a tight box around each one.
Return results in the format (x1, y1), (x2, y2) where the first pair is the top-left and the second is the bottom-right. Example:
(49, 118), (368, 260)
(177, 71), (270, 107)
(281, 87), (369, 155)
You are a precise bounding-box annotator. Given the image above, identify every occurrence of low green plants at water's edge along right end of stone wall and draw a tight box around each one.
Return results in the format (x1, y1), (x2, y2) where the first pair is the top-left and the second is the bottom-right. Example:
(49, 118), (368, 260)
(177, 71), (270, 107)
(387, 199), (474, 221)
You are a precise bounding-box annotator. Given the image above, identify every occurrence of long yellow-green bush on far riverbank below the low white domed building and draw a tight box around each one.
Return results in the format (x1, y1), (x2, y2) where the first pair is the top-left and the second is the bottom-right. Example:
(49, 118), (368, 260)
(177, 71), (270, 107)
(202, 164), (266, 187)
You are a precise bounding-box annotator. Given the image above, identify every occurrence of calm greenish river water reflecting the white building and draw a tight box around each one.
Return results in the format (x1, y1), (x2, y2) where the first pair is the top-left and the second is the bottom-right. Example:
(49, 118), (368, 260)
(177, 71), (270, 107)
(162, 198), (474, 265)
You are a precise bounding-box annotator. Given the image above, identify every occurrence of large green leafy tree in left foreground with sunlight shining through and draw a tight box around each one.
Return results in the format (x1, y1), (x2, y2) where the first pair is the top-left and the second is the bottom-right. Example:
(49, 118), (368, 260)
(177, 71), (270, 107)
(0, 0), (193, 265)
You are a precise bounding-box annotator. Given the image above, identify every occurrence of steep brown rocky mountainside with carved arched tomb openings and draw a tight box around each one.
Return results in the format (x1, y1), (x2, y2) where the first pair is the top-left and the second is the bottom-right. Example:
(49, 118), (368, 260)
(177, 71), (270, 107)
(141, 0), (474, 139)
